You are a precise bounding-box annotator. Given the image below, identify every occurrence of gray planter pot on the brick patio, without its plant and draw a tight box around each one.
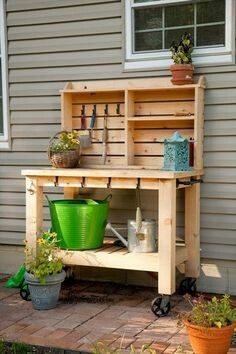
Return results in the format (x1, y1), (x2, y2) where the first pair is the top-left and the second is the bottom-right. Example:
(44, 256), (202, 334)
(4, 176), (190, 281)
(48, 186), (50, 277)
(25, 270), (66, 310)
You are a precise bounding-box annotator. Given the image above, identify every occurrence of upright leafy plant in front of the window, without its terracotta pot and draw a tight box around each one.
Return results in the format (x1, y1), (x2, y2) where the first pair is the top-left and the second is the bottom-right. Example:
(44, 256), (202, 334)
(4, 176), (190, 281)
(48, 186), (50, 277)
(170, 33), (193, 64)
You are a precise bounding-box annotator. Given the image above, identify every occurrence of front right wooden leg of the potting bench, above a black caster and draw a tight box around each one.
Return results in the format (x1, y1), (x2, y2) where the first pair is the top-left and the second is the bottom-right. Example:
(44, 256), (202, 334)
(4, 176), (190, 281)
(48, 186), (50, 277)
(158, 180), (176, 295)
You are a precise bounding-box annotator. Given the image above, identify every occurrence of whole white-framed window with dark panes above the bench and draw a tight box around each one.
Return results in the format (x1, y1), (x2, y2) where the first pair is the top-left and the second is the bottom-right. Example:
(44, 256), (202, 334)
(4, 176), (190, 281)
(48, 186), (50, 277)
(125, 0), (235, 69)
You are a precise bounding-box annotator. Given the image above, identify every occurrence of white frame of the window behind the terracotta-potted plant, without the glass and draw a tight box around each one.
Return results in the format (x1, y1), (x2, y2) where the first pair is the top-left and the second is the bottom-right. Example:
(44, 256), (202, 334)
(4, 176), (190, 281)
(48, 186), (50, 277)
(124, 0), (235, 70)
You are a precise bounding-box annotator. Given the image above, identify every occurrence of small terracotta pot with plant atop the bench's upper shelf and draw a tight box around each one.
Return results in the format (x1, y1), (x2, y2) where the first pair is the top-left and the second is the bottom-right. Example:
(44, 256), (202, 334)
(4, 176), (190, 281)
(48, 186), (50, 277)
(170, 33), (194, 85)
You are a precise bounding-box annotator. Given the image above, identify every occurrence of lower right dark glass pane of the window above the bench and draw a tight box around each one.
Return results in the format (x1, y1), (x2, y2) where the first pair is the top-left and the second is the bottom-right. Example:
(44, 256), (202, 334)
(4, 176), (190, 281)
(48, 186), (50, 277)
(197, 25), (225, 47)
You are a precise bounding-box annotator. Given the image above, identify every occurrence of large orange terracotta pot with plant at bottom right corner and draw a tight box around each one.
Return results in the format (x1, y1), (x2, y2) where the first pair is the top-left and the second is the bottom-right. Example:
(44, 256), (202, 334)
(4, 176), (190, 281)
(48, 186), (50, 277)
(181, 295), (236, 354)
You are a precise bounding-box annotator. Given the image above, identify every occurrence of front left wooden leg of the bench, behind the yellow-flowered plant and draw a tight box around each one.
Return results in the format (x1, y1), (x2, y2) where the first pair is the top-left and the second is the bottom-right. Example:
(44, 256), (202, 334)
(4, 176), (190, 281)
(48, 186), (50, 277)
(26, 177), (43, 250)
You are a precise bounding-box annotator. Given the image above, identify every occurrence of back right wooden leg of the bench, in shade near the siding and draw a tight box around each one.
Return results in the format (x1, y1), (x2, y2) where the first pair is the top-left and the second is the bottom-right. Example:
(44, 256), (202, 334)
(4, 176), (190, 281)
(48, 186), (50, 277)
(185, 184), (200, 278)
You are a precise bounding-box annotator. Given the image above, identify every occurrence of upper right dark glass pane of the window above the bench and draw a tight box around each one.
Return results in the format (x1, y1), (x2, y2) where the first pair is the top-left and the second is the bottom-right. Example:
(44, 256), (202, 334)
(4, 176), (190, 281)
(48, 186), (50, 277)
(197, 0), (225, 24)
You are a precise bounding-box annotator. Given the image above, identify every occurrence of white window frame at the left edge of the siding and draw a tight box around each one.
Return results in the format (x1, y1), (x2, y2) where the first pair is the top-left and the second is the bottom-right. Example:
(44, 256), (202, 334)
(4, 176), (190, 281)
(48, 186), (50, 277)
(0, 0), (10, 150)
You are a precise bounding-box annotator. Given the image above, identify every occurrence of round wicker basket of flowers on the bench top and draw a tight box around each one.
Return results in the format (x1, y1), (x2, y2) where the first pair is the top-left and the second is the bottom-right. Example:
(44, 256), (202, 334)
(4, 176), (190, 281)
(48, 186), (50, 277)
(48, 130), (80, 168)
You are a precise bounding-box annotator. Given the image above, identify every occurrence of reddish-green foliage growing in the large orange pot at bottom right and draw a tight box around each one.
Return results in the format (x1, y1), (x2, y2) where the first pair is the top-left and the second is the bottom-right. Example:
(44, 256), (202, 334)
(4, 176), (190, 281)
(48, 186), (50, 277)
(181, 295), (236, 328)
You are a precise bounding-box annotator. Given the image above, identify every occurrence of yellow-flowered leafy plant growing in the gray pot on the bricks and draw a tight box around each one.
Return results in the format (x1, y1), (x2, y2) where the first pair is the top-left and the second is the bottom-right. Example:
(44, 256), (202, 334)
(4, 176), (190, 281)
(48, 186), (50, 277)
(25, 232), (63, 283)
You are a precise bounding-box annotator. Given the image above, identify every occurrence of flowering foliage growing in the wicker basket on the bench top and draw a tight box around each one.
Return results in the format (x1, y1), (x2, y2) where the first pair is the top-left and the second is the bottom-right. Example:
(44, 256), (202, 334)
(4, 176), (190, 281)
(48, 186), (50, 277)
(50, 130), (80, 151)
